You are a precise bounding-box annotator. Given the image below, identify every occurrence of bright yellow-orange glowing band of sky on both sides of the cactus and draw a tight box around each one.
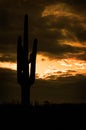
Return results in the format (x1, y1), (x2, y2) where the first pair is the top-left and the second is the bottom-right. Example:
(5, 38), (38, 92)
(0, 54), (86, 80)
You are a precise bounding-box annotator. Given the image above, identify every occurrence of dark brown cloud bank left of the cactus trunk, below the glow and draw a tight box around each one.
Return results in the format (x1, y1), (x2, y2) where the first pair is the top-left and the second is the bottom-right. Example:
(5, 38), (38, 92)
(0, 68), (20, 103)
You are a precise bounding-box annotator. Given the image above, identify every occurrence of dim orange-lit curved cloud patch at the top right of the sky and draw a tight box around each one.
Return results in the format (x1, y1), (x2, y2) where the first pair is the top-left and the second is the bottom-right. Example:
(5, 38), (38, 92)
(42, 3), (85, 21)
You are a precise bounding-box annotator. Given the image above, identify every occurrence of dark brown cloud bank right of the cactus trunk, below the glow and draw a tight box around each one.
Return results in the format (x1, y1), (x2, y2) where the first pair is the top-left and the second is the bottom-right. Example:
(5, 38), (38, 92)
(31, 75), (86, 103)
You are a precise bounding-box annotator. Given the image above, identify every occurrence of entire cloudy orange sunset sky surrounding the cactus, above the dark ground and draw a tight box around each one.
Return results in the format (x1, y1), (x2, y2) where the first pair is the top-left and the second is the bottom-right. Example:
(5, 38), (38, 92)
(0, 0), (86, 103)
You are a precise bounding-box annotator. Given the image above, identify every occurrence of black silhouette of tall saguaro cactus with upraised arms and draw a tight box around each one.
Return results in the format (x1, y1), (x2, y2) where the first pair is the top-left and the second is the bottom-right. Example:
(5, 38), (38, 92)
(17, 14), (38, 105)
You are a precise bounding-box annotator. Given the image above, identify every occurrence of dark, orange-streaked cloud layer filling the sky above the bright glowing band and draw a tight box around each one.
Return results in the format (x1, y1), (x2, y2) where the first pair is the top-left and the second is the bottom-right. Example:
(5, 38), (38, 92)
(0, 0), (86, 61)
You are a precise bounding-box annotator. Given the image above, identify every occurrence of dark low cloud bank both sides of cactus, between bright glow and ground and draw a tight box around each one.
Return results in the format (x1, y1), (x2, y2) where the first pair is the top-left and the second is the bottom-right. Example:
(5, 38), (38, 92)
(0, 69), (86, 103)
